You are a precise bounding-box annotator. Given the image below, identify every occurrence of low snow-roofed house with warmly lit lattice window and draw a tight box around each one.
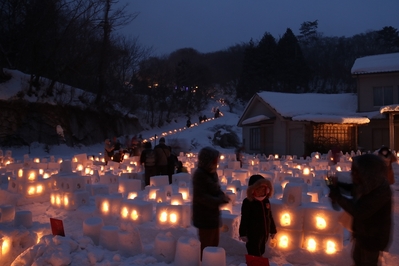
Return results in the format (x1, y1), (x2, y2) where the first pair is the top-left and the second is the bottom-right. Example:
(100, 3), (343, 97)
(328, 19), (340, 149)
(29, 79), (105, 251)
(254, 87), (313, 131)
(238, 91), (372, 156)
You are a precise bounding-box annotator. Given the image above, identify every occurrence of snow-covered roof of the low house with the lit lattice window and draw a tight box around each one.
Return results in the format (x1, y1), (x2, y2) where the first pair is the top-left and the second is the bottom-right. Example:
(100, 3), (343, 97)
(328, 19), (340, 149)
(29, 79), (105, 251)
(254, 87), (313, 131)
(258, 91), (372, 124)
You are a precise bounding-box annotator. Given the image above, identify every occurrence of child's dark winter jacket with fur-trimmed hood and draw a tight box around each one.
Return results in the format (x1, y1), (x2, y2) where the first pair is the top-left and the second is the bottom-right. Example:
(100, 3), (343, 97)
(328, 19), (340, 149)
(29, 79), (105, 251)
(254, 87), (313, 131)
(239, 179), (277, 241)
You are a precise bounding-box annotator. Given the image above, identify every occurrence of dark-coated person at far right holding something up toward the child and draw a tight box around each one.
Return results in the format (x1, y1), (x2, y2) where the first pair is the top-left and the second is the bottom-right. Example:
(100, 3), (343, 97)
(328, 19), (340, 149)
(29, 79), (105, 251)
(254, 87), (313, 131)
(329, 154), (392, 266)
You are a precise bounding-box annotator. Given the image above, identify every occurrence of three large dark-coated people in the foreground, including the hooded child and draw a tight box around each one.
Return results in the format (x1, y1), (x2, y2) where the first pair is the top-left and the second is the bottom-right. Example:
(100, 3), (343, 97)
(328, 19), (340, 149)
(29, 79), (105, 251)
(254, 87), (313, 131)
(192, 147), (396, 266)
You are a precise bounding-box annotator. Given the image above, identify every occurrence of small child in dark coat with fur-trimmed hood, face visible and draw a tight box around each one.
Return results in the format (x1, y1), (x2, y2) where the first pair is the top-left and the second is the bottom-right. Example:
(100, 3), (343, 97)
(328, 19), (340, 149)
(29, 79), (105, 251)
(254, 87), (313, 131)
(239, 175), (277, 257)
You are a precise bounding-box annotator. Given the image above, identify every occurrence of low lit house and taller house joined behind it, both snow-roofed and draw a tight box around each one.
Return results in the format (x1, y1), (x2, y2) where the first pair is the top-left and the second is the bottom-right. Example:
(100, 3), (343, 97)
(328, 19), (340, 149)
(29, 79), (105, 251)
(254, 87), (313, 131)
(238, 53), (399, 156)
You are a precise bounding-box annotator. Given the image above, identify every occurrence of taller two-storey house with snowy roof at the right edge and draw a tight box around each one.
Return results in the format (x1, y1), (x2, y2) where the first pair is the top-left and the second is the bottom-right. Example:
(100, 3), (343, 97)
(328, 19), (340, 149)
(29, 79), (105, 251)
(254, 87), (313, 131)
(351, 53), (399, 151)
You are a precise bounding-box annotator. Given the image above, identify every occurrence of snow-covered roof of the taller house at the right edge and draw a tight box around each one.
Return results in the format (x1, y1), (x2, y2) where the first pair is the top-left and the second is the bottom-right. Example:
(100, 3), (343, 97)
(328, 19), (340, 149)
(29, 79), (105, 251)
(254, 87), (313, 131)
(351, 53), (399, 74)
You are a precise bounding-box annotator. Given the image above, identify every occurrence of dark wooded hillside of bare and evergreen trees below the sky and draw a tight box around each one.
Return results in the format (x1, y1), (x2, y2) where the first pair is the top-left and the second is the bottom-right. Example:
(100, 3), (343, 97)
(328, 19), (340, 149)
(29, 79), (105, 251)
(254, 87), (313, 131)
(0, 0), (399, 126)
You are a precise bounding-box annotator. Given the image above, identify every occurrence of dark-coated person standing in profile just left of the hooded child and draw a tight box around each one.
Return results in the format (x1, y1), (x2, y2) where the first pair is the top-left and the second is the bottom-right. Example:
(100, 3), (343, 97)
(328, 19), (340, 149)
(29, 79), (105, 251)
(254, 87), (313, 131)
(192, 147), (229, 257)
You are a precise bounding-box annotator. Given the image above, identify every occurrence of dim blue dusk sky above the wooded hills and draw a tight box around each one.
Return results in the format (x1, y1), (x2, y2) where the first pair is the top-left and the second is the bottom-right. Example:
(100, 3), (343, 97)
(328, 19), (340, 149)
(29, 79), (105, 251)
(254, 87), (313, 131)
(120, 0), (399, 55)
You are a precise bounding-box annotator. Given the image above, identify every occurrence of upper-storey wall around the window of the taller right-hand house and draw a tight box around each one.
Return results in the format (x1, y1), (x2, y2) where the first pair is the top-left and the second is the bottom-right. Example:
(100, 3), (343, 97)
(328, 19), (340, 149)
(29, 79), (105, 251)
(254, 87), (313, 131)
(356, 72), (399, 112)
